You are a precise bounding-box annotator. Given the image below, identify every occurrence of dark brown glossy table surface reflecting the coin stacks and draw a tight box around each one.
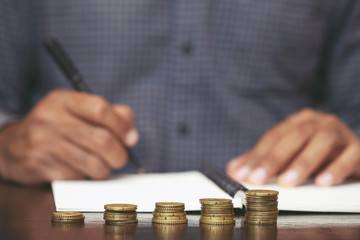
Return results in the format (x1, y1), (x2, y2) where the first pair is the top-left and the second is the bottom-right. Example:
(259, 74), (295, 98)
(0, 181), (360, 240)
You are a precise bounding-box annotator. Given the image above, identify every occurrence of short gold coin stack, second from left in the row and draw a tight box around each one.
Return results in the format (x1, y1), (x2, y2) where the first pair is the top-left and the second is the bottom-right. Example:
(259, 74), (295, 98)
(104, 203), (138, 225)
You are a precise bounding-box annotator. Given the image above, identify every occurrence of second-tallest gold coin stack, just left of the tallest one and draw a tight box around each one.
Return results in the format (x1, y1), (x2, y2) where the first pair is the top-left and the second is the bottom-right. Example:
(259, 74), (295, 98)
(200, 198), (235, 225)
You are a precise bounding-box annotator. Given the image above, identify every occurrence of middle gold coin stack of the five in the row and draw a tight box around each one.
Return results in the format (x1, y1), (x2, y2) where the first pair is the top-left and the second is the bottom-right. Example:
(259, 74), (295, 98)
(152, 202), (188, 224)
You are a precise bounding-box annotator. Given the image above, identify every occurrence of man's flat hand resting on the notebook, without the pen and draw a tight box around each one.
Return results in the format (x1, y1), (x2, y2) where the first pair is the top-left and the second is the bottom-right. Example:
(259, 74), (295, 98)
(227, 109), (360, 187)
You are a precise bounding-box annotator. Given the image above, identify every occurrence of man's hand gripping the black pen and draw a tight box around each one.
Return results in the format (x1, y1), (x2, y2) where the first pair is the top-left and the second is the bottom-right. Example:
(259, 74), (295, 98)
(0, 90), (139, 185)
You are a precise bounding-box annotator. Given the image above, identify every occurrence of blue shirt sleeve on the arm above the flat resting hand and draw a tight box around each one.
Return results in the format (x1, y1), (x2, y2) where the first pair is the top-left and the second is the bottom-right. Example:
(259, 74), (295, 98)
(325, 0), (360, 136)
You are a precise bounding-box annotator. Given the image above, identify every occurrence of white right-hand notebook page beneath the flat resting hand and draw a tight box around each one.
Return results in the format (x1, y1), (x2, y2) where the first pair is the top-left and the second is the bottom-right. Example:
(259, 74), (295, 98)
(244, 181), (360, 213)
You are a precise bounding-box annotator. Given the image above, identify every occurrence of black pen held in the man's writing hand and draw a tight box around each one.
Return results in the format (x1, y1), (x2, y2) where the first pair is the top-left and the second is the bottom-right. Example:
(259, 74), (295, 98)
(43, 38), (145, 173)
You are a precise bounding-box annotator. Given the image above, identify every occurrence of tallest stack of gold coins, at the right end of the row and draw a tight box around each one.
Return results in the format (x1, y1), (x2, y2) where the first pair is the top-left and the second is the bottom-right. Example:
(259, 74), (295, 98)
(245, 189), (279, 224)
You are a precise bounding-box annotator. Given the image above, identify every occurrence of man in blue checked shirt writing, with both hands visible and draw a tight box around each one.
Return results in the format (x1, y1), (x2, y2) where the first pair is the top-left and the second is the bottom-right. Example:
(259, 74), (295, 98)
(0, 0), (360, 186)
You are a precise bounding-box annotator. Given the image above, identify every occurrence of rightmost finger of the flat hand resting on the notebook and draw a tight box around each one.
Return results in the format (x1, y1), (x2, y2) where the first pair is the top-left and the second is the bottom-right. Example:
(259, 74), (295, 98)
(315, 145), (360, 187)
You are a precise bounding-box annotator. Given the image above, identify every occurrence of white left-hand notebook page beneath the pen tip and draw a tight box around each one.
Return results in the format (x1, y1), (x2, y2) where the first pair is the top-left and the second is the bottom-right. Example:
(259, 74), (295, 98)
(52, 171), (241, 212)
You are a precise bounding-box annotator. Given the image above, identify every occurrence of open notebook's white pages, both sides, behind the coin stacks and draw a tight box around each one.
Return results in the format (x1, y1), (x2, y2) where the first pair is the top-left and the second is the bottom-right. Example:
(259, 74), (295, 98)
(52, 171), (360, 213)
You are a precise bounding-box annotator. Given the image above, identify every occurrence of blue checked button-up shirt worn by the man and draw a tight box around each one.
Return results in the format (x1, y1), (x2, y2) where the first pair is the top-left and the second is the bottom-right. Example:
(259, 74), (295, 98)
(0, 0), (360, 171)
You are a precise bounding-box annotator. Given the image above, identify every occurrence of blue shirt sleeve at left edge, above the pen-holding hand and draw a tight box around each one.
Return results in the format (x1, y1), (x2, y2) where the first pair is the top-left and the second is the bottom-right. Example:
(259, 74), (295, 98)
(0, 0), (34, 118)
